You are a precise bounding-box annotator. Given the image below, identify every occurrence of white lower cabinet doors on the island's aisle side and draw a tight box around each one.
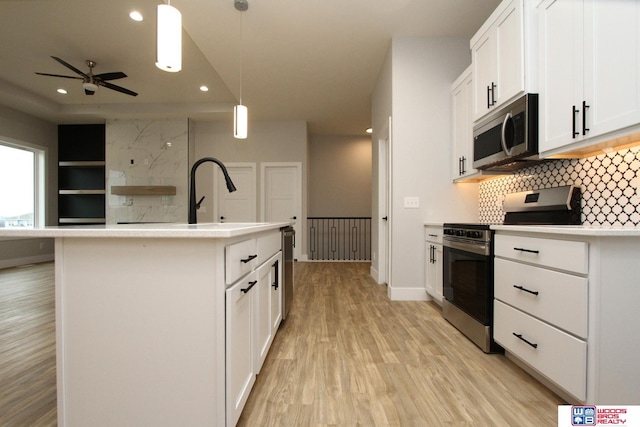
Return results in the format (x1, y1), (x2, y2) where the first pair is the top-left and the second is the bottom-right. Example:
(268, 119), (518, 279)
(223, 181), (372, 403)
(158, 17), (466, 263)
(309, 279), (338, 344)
(226, 239), (282, 426)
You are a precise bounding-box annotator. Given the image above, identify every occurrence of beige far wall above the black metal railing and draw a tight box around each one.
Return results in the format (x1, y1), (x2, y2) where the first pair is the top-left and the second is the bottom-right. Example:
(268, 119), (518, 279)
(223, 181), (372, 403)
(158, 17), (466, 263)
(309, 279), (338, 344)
(308, 135), (371, 217)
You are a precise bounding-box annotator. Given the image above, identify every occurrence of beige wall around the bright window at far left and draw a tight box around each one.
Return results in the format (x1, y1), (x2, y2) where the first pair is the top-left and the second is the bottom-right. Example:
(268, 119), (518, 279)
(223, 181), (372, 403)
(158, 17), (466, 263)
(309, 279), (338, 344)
(0, 106), (58, 268)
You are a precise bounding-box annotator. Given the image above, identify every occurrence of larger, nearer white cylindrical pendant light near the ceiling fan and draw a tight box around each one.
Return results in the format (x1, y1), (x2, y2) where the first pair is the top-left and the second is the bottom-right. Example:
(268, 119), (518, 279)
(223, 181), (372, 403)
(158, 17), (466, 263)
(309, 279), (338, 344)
(156, 0), (182, 73)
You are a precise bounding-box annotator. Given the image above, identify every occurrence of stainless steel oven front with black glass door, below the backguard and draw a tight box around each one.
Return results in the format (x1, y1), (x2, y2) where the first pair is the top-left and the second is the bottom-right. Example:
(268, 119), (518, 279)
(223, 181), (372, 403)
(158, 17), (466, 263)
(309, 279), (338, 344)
(442, 224), (502, 353)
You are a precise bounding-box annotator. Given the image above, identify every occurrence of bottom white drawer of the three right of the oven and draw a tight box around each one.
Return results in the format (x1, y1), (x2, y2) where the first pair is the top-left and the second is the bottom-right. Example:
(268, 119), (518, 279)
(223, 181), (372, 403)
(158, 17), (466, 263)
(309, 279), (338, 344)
(494, 300), (587, 401)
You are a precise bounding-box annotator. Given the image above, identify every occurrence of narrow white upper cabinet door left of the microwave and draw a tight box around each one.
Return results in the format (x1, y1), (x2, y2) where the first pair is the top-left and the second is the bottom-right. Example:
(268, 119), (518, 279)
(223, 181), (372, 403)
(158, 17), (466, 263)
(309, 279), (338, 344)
(451, 66), (477, 181)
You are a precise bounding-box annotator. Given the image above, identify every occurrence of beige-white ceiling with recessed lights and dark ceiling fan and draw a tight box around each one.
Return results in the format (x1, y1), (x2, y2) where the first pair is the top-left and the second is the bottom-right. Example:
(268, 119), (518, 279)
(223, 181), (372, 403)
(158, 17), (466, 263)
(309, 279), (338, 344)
(0, 0), (499, 135)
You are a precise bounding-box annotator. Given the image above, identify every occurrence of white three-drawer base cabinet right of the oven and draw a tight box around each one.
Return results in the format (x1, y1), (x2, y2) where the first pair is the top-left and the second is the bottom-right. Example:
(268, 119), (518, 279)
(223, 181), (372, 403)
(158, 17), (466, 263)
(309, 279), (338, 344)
(494, 231), (640, 405)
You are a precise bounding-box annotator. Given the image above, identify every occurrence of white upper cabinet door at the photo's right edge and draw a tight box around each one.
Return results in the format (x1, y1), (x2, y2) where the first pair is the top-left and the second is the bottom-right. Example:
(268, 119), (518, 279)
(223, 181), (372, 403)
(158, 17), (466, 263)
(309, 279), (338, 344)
(581, 0), (640, 138)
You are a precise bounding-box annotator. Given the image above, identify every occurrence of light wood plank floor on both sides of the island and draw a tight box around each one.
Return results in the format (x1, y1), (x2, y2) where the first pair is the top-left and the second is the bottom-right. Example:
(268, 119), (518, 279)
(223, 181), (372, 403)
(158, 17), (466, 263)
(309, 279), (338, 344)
(0, 263), (562, 427)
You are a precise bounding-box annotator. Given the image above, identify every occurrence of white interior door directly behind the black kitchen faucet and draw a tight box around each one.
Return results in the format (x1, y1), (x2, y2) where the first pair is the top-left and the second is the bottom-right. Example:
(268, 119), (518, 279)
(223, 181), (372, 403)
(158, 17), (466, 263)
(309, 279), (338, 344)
(213, 163), (257, 222)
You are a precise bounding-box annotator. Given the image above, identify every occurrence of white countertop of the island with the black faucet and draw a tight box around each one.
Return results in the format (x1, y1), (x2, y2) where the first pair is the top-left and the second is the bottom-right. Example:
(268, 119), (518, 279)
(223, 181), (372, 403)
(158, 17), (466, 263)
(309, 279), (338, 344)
(0, 222), (292, 239)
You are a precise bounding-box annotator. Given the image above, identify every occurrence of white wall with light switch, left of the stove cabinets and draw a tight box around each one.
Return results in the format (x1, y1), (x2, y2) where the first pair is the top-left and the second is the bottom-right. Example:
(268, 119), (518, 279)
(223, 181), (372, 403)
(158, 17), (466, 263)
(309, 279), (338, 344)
(373, 37), (478, 300)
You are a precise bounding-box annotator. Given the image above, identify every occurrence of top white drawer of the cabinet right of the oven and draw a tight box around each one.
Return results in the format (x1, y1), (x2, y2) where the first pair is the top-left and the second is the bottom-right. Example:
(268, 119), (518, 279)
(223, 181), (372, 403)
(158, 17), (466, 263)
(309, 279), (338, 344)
(495, 234), (589, 274)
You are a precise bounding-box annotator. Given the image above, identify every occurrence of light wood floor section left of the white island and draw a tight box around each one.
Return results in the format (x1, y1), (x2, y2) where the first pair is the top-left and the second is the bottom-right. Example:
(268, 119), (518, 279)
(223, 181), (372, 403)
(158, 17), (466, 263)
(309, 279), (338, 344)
(0, 263), (56, 427)
